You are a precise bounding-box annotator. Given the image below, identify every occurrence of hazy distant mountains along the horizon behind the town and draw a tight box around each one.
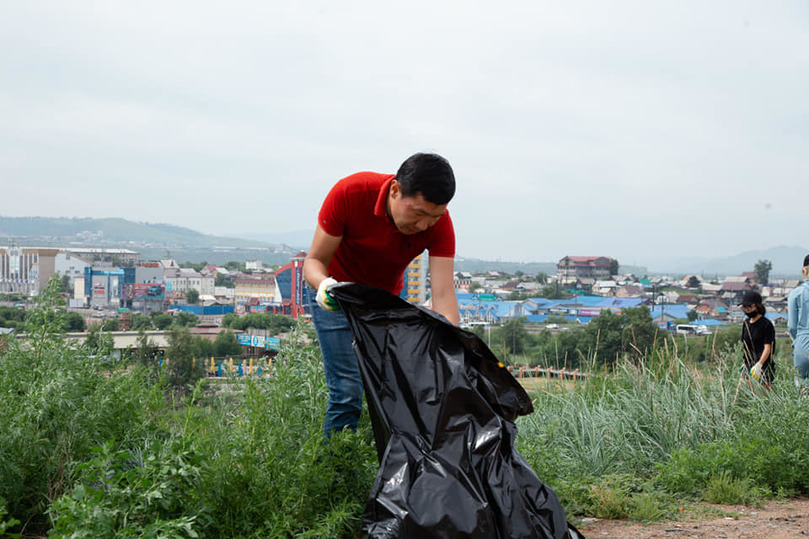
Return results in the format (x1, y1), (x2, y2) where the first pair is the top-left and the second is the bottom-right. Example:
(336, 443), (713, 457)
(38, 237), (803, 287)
(0, 216), (809, 278)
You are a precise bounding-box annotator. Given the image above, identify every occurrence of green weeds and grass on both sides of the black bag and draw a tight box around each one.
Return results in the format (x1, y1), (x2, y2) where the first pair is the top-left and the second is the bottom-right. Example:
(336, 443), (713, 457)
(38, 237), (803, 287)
(0, 278), (809, 538)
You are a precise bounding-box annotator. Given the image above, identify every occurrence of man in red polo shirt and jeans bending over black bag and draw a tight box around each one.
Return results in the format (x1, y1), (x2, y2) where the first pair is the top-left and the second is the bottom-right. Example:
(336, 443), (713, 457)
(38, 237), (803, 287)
(303, 153), (460, 437)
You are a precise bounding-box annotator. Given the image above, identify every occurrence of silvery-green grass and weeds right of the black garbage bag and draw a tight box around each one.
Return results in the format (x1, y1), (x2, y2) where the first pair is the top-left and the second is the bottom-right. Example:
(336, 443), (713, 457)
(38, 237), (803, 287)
(518, 351), (809, 516)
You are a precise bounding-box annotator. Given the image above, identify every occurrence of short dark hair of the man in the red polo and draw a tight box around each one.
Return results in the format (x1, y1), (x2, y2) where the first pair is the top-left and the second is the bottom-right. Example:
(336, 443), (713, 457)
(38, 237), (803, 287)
(396, 153), (455, 206)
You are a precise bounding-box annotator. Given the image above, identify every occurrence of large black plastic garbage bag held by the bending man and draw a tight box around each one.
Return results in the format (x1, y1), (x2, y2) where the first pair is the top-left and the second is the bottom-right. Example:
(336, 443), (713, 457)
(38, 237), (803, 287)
(329, 283), (582, 539)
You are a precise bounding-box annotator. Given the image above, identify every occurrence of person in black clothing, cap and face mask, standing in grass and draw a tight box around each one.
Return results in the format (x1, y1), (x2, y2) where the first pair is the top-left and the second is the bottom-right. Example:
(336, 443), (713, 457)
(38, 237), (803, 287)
(739, 290), (775, 389)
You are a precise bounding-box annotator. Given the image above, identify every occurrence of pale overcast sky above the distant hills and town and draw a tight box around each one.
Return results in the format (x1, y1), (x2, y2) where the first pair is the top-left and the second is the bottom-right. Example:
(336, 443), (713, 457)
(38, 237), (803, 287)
(0, 0), (809, 264)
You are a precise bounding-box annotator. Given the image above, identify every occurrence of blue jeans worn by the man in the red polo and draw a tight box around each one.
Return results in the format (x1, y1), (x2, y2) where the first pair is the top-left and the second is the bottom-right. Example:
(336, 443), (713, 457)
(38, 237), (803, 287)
(311, 293), (362, 438)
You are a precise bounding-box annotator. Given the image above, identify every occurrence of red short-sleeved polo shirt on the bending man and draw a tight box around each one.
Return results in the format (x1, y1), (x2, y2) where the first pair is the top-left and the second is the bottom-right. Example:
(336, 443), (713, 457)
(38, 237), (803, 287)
(318, 172), (455, 294)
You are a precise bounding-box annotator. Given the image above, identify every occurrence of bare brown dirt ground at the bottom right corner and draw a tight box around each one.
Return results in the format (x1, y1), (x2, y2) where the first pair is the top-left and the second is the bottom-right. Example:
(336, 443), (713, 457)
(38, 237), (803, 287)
(577, 499), (809, 539)
